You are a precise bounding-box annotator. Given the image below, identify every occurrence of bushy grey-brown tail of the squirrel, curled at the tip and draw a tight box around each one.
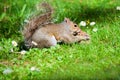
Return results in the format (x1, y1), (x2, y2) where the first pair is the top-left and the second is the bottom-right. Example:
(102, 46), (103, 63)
(23, 3), (53, 40)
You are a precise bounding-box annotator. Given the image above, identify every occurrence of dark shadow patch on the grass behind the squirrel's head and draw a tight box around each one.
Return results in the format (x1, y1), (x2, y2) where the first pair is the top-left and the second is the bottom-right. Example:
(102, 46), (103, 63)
(71, 6), (119, 23)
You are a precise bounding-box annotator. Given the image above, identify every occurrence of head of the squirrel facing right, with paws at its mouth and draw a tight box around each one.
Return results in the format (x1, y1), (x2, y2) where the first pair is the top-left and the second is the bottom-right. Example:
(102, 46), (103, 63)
(64, 18), (90, 42)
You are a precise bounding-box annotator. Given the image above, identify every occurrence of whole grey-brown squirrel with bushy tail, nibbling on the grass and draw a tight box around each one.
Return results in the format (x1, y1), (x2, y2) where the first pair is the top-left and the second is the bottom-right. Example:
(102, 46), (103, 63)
(23, 3), (90, 48)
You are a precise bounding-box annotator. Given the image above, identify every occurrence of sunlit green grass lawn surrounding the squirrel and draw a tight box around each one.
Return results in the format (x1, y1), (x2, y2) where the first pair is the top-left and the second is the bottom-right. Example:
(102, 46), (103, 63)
(0, 0), (120, 80)
